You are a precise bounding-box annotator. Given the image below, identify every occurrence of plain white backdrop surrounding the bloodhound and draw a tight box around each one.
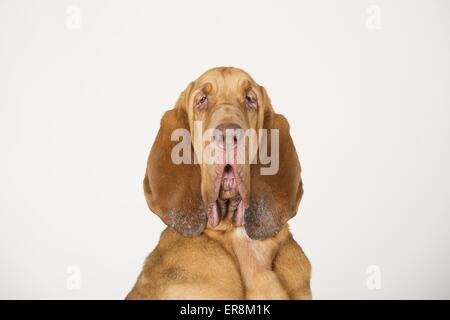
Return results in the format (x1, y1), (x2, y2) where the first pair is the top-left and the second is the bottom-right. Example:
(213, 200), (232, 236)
(0, 0), (450, 299)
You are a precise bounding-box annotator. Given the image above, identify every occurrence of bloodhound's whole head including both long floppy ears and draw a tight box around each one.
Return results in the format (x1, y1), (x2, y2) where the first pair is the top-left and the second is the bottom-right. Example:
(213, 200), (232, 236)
(144, 68), (303, 239)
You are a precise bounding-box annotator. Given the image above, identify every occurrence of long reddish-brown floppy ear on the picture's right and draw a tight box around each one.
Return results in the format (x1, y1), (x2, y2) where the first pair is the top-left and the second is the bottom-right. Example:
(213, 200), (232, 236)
(244, 87), (303, 240)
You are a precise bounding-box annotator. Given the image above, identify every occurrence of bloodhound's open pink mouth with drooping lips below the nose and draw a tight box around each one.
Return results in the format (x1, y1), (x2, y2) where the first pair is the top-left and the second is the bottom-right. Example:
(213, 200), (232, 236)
(208, 164), (245, 227)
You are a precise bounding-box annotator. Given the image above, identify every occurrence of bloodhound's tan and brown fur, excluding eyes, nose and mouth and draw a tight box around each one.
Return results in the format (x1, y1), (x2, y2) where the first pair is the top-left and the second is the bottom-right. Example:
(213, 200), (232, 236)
(127, 68), (311, 299)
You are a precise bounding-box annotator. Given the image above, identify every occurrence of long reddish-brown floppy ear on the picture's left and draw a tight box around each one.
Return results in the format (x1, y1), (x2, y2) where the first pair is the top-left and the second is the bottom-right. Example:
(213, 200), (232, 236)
(144, 98), (206, 236)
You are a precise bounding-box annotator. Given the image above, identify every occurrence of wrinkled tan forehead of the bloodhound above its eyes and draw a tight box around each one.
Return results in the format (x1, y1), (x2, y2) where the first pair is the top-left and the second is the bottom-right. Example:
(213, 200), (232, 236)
(195, 68), (256, 94)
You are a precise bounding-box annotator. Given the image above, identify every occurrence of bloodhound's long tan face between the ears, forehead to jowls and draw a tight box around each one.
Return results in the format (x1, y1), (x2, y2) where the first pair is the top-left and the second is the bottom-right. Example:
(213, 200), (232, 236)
(180, 68), (265, 227)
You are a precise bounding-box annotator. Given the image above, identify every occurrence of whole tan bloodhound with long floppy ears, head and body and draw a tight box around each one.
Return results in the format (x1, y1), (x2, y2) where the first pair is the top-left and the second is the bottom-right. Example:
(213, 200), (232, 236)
(126, 67), (311, 299)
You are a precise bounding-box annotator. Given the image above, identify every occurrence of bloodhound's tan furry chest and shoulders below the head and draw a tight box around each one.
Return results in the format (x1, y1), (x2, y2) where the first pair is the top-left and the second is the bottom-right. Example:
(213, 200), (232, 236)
(127, 221), (311, 300)
